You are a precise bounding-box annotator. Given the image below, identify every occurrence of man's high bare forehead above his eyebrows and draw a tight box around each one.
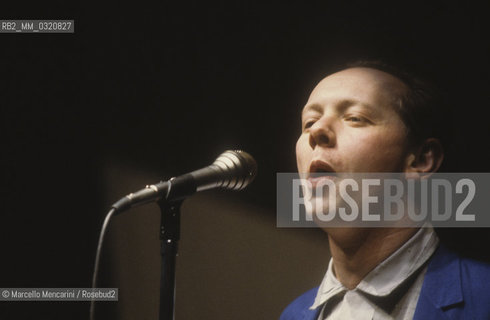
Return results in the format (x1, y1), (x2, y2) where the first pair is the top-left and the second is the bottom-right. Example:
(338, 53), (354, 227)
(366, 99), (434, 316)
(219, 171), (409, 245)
(306, 68), (406, 112)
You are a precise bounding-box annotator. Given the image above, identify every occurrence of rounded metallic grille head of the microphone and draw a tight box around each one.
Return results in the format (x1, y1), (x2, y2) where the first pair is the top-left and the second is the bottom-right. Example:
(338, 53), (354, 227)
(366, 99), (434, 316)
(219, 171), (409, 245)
(213, 150), (257, 190)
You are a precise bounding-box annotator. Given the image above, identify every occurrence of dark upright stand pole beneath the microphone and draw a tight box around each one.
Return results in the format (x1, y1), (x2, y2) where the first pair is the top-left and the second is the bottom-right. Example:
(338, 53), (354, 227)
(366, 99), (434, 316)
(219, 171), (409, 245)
(158, 199), (183, 320)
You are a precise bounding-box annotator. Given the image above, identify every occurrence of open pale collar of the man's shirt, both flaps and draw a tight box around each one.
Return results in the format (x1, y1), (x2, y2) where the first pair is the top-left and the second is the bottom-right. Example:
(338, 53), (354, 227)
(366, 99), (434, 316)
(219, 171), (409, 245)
(310, 225), (439, 309)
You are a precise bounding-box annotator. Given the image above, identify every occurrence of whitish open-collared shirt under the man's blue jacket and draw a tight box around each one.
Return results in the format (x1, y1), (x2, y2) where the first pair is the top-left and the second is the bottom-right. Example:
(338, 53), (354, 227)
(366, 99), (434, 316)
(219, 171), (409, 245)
(310, 226), (439, 320)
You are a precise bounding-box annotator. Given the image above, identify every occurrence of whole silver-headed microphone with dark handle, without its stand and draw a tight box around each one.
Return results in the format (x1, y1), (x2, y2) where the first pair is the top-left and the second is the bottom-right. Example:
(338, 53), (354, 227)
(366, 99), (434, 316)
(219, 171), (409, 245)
(112, 150), (257, 213)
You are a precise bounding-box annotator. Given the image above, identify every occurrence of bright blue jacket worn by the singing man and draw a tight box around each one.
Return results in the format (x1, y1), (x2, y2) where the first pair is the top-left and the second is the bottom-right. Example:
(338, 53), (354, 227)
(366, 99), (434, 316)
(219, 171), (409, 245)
(280, 246), (490, 320)
